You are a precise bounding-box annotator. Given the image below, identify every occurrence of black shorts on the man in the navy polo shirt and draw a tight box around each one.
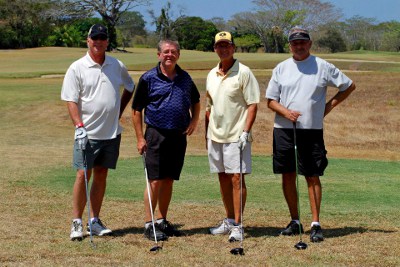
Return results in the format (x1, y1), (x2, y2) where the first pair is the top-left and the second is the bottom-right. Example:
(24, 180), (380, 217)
(145, 126), (187, 180)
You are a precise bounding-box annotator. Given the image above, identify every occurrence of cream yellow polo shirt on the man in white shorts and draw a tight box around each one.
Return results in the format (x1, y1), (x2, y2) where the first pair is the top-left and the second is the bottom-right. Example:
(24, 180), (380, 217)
(206, 60), (260, 143)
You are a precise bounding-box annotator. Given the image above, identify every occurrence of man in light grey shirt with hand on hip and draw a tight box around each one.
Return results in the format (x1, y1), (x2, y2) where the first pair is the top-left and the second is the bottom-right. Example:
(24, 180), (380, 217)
(266, 28), (356, 242)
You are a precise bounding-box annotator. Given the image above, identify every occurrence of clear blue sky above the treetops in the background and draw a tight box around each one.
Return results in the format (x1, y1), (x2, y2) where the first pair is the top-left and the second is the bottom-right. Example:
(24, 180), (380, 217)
(135, 0), (400, 29)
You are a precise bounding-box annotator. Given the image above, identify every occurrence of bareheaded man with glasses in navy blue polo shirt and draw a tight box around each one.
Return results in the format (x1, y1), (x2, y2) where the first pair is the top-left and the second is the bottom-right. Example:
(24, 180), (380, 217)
(132, 40), (200, 243)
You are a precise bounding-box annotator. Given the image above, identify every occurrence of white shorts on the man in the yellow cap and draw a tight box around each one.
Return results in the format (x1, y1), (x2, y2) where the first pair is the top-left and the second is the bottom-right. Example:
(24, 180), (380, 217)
(207, 139), (251, 174)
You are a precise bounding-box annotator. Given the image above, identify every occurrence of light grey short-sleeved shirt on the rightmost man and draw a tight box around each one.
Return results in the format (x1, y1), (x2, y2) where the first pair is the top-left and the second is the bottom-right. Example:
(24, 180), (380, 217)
(266, 55), (353, 129)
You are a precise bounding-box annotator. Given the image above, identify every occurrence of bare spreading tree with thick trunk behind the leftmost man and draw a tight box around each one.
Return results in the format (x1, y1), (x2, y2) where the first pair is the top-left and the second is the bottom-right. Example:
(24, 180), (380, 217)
(65, 0), (150, 50)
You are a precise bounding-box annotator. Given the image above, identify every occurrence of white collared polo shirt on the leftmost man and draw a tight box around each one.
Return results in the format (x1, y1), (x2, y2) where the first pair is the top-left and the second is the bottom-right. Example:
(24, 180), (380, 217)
(61, 53), (135, 140)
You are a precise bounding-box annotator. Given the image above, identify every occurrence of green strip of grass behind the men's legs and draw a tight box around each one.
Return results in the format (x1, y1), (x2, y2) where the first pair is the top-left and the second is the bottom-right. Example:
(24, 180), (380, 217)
(39, 156), (400, 220)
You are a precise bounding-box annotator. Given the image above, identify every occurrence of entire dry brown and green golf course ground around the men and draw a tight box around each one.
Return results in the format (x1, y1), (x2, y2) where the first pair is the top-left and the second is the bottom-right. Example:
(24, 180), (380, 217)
(0, 48), (400, 266)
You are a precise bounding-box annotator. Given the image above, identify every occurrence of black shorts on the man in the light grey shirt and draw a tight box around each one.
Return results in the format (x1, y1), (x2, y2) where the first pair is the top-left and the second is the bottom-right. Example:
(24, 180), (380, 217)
(273, 128), (328, 177)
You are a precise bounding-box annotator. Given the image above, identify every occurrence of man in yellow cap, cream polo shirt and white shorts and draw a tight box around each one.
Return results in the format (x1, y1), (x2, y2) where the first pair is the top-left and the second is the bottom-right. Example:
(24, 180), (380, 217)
(205, 32), (260, 242)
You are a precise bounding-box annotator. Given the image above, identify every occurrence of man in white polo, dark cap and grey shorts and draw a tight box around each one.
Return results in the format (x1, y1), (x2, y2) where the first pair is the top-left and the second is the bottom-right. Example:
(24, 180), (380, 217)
(61, 24), (134, 243)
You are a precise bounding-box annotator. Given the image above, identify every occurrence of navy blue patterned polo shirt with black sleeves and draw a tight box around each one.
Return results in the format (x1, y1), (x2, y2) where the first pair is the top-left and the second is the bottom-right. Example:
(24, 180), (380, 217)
(132, 63), (200, 130)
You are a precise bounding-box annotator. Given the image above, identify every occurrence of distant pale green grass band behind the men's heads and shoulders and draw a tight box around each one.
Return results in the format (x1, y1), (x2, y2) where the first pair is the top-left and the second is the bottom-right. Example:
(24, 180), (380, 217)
(0, 47), (400, 78)
